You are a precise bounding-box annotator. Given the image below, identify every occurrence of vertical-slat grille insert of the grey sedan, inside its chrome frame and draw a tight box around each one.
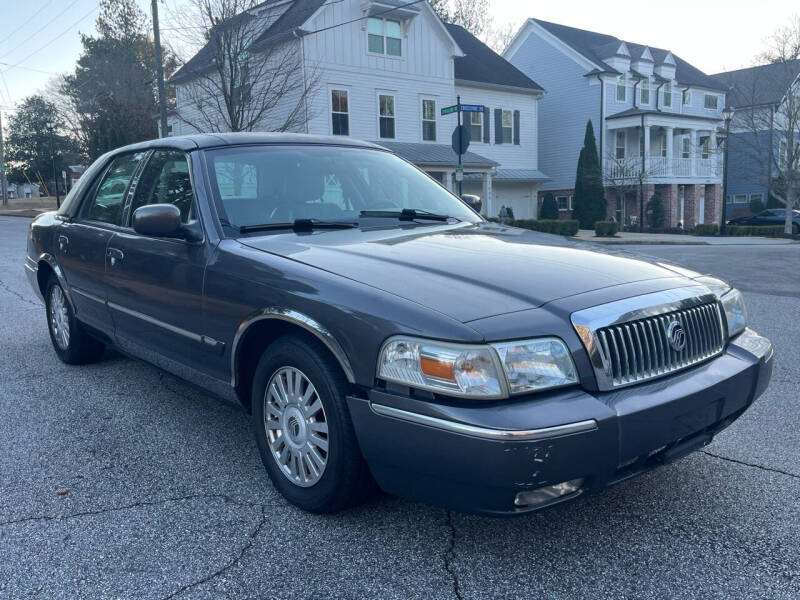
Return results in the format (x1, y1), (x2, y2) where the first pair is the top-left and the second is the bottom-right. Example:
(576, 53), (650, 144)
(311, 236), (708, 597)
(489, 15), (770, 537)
(595, 301), (725, 387)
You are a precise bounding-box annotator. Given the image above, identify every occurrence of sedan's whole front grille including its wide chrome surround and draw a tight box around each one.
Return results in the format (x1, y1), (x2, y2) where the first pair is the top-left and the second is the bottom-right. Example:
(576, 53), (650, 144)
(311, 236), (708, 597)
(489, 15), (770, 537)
(570, 285), (728, 390)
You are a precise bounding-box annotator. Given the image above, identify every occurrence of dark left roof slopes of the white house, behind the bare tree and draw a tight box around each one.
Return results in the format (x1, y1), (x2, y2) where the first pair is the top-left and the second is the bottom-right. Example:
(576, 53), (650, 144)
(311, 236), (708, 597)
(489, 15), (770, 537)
(169, 0), (326, 83)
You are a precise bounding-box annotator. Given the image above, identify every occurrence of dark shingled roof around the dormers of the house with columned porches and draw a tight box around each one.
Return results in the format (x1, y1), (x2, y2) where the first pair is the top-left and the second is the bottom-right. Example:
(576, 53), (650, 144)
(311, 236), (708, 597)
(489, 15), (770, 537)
(531, 19), (725, 91)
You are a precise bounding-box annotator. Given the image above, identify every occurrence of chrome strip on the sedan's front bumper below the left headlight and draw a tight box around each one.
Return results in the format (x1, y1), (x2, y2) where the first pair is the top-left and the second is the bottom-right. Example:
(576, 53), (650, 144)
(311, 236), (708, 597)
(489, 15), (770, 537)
(369, 402), (597, 442)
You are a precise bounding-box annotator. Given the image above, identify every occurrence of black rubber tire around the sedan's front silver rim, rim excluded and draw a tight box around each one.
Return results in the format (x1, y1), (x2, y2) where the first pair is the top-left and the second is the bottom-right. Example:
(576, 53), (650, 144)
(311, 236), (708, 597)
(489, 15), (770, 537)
(252, 335), (374, 513)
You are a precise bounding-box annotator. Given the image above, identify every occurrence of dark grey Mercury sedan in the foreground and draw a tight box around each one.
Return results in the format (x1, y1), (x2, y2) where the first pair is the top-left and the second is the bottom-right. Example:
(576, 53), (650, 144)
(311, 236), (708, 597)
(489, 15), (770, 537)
(25, 134), (773, 515)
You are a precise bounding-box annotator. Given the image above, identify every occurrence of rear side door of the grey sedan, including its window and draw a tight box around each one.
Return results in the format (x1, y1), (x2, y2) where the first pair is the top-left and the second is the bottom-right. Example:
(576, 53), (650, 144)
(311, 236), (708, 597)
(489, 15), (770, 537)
(55, 152), (145, 336)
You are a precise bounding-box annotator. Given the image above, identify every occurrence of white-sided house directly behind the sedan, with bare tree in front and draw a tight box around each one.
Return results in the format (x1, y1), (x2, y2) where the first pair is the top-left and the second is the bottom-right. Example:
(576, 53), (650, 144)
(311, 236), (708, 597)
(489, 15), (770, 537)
(170, 0), (547, 218)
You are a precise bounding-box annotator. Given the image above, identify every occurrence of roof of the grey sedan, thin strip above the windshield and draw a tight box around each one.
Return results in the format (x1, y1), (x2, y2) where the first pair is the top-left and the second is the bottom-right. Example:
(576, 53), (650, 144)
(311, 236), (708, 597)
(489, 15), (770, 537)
(104, 132), (382, 154)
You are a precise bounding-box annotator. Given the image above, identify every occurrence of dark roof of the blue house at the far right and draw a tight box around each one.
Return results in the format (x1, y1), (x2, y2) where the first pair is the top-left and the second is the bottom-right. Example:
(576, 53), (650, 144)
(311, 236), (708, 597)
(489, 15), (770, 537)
(712, 59), (800, 108)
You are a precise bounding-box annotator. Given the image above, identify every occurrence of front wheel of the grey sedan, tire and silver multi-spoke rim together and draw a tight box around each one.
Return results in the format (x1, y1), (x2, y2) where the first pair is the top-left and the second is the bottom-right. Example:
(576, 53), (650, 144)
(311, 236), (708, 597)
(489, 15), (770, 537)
(252, 336), (372, 513)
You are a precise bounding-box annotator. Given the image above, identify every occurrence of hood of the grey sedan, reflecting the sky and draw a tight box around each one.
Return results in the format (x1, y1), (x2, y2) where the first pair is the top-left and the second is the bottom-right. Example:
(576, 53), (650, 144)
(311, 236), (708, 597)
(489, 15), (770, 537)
(238, 223), (692, 322)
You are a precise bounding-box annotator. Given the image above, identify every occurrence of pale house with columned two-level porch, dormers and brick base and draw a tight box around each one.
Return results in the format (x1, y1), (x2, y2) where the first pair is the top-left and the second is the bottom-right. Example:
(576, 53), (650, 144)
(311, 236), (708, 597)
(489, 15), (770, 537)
(504, 19), (725, 228)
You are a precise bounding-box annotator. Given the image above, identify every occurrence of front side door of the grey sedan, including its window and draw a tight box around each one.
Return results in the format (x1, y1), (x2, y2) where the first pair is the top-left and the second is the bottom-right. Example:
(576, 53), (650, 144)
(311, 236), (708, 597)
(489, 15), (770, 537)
(106, 149), (216, 370)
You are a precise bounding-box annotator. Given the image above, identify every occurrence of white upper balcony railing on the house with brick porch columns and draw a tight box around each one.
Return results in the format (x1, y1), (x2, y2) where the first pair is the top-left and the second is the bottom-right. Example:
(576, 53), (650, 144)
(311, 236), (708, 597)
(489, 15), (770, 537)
(604, 156), (722, 181)
